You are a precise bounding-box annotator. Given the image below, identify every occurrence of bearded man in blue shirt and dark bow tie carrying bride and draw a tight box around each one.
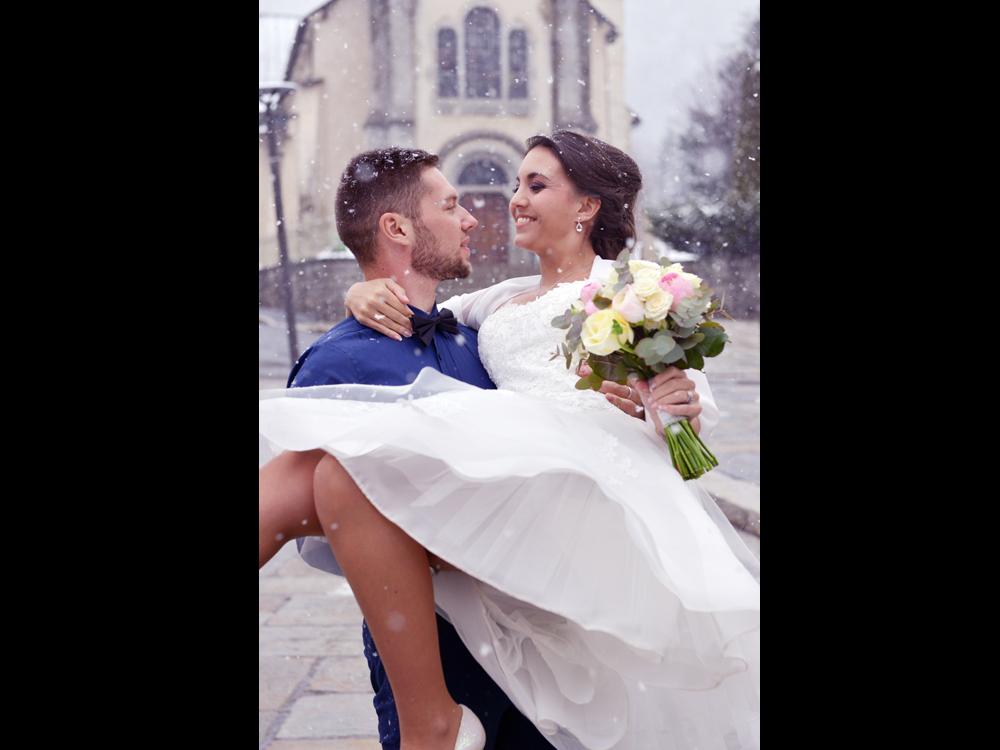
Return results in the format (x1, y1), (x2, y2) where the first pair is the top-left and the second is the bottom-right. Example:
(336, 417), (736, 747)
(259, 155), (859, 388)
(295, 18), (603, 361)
(289, 148), (552, 750)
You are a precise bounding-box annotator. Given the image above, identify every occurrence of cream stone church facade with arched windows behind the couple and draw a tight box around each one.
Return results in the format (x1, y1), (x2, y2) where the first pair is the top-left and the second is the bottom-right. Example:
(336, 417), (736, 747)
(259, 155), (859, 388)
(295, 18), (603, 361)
(258, 0), (634, 294)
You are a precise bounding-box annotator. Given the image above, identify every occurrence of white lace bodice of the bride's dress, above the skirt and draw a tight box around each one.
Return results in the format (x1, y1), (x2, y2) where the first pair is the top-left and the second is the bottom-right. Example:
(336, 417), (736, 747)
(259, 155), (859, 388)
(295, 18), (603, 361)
(479, 281), (617, 411)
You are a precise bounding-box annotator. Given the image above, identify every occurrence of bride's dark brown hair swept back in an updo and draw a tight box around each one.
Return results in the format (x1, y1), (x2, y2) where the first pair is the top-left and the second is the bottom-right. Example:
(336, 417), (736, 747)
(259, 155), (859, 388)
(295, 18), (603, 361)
(525, 130), (642, 260)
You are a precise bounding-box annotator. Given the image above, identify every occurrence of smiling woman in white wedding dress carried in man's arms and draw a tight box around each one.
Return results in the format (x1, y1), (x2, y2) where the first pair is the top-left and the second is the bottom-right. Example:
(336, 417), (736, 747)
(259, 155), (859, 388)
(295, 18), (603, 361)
(260, 132), (760, 750)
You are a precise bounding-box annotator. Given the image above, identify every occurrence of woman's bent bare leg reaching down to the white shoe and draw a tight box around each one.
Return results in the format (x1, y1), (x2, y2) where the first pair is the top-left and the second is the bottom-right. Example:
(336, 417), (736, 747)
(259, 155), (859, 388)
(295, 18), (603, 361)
(314, 456), (462, 750)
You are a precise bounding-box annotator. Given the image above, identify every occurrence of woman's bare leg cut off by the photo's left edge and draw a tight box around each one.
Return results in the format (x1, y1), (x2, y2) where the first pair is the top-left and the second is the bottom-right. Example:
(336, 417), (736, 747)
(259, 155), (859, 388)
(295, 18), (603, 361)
(257, 451), (327, 570)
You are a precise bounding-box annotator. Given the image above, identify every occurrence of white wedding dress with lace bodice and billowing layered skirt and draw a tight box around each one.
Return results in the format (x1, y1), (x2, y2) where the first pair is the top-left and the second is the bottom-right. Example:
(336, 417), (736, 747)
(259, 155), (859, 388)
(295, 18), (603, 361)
(260, 282), (760, 750)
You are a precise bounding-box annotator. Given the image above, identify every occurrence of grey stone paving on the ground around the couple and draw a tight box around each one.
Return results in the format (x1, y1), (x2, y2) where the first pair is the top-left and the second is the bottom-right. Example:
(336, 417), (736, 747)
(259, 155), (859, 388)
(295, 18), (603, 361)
(257, 321), (760, 750)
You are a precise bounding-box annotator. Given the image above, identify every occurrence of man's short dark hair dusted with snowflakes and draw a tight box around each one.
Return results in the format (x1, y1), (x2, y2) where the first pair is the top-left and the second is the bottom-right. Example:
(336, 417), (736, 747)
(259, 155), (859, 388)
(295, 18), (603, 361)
(336, 147), (439, 268)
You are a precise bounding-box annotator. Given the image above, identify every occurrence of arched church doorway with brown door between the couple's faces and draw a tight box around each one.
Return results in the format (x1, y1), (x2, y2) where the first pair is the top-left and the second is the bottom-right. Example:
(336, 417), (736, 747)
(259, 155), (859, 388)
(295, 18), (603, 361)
(458, 157), (511, 266)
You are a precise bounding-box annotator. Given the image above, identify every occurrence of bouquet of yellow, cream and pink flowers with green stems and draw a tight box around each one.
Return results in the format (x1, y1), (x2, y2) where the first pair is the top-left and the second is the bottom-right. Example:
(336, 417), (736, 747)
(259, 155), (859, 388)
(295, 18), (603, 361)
(552, 250), (729, 480)
